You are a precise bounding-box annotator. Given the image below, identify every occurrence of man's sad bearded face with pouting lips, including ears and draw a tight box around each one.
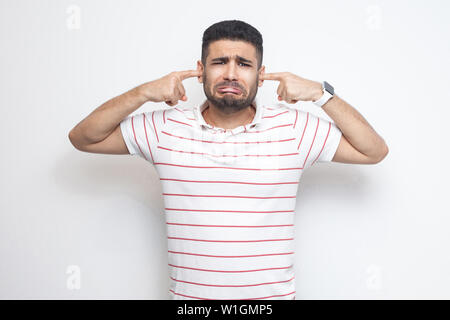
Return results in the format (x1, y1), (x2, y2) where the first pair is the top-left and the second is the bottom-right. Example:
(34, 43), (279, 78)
(197, 40), (265, 114)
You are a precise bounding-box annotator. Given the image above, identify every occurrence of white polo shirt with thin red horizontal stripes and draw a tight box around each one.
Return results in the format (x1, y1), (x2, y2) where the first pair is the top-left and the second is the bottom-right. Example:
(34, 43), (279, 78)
(120, 100), (342, 300)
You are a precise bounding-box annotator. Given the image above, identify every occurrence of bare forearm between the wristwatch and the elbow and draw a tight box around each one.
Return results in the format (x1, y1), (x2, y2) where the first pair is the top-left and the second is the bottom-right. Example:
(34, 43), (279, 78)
(322, 95), (387, 159)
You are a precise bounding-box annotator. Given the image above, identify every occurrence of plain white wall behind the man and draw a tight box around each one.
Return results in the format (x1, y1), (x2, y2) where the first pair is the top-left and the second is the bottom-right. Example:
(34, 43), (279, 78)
(0, 0), (450, 299)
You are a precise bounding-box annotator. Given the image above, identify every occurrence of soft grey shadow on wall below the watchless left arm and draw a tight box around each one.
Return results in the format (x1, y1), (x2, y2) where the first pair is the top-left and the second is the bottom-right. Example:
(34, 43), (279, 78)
(52, 150), (164, 213)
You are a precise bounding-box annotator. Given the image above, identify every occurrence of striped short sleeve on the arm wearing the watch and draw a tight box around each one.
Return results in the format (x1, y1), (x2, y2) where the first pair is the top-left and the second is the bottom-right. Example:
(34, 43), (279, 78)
(296, 110), (342, 169)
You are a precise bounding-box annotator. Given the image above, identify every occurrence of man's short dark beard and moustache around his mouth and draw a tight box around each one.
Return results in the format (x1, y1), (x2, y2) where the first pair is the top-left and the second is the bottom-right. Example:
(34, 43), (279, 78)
(203, 72), (259, 114)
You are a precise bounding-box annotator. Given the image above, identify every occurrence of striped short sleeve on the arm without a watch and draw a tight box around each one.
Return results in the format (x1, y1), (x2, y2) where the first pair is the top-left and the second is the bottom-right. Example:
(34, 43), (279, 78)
(120, 111), (159, 164)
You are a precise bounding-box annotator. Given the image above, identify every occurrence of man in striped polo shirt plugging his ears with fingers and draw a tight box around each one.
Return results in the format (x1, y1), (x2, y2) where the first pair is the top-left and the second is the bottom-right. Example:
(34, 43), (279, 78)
(69, 20), (388, 299)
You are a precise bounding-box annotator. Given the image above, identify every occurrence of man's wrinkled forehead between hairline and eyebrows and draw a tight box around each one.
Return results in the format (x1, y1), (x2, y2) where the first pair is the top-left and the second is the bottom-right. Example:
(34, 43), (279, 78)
(208, 39), (256, 61)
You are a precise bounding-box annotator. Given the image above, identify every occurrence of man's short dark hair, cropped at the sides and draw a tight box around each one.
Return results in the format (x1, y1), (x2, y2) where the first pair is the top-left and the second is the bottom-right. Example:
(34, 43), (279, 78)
(202, 20), (263, 69)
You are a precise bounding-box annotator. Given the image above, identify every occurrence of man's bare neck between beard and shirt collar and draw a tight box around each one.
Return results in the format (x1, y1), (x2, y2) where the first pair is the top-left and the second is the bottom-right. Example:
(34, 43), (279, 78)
(202, 102), (256, 129)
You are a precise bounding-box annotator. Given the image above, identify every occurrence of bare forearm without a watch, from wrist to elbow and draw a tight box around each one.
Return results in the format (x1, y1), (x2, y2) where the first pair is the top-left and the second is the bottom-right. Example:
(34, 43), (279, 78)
(69, 87), (148, 145)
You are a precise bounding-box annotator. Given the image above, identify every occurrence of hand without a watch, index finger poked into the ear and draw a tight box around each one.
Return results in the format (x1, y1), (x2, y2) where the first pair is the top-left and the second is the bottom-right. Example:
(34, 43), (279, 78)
(139, 70), (202, 106)
